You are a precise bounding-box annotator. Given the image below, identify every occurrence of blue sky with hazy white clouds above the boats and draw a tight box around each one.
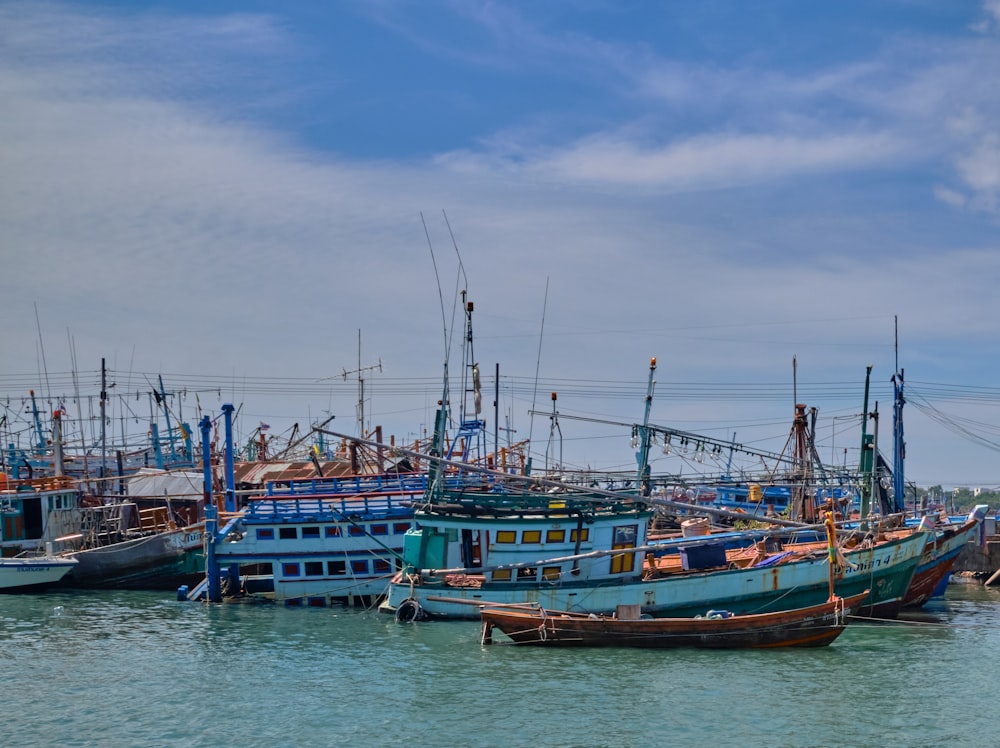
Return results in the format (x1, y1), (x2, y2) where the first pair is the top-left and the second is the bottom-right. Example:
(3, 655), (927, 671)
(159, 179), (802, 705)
(0, 0), (1000, 488)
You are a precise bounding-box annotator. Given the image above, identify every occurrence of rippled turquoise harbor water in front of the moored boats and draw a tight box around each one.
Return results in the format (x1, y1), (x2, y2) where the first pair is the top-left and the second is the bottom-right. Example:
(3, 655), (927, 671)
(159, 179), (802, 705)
(0, 584), (1000, 748)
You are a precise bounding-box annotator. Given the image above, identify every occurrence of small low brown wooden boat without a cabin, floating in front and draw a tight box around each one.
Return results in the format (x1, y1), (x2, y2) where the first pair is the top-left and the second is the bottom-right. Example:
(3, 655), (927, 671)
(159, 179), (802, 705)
(480, 590), (868, 649)
